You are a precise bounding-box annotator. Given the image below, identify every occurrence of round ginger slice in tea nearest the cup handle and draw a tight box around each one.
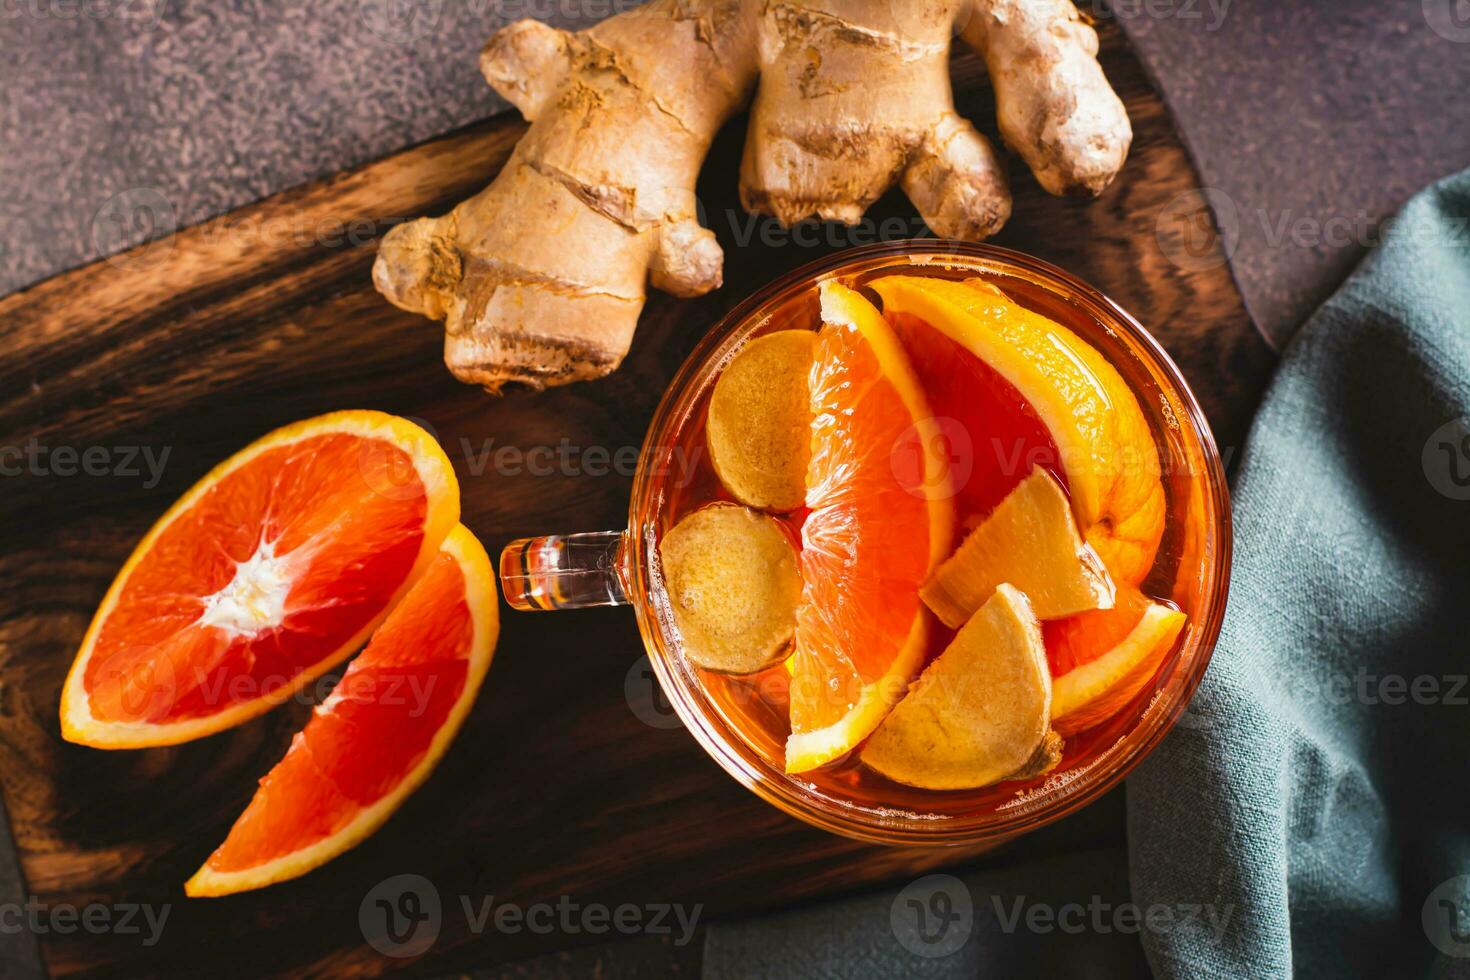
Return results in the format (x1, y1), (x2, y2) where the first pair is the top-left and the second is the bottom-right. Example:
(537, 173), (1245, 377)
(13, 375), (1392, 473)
(659, 502), (801, 674)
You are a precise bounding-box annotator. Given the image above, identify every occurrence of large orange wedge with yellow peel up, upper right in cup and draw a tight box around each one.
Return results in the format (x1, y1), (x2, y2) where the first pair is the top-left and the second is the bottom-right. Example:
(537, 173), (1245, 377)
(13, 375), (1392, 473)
(869, 276), (1164, 585)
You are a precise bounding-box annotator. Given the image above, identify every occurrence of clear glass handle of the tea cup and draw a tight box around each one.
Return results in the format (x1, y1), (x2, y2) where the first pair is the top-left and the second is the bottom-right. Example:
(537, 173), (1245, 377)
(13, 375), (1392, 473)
(500, 530), (628, 611)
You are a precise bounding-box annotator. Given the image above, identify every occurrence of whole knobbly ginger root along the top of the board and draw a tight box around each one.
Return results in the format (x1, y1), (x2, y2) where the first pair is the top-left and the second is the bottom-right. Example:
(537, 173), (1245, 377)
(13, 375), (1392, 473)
(373, 0), (1132, 391)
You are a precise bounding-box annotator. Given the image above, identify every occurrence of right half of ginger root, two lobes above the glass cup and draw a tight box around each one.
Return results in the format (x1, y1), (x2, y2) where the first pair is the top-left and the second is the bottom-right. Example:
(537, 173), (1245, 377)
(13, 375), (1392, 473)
(741, 0), (1133, 230)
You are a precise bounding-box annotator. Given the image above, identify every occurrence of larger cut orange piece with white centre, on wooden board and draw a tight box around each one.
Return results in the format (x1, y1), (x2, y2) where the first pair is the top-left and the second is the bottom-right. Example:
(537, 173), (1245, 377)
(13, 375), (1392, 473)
(62, 411), (459, 748)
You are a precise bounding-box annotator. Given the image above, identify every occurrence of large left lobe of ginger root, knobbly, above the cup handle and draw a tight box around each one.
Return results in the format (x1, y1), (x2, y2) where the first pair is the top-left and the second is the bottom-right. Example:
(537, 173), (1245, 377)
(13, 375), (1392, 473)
(373, 0), (754, 391)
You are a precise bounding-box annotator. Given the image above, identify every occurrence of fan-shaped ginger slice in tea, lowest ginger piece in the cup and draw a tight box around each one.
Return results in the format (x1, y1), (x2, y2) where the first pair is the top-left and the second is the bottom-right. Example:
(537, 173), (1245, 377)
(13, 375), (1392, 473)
(861, 583), (1061, 789)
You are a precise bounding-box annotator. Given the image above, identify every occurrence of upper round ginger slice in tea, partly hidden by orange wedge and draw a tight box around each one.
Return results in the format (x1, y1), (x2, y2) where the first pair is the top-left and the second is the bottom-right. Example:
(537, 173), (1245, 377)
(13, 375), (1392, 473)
(706, 331), (816, 511)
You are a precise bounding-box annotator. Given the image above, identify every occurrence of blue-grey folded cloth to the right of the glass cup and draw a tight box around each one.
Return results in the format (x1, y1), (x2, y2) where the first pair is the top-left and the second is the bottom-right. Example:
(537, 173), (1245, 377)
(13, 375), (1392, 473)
(1127, 172), (1470, 977)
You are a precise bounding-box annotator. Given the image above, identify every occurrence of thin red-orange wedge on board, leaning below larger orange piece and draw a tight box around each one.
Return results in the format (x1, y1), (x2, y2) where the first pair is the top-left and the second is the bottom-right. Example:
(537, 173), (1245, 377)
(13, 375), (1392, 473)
(184, 527), (500, 896)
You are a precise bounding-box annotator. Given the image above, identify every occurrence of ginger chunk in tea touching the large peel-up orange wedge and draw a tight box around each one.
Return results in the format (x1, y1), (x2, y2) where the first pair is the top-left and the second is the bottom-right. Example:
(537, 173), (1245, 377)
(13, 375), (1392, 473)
(919, 467), (1114, 629)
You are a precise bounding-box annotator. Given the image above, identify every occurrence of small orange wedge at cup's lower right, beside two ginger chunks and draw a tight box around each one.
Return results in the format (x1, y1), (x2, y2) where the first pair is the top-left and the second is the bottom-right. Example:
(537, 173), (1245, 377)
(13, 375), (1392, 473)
(1042, 588), (1186, 735)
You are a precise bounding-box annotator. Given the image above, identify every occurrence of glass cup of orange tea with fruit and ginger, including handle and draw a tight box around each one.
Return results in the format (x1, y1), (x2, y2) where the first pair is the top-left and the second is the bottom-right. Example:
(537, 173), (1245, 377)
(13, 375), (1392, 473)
(503, 242), (1229, 842)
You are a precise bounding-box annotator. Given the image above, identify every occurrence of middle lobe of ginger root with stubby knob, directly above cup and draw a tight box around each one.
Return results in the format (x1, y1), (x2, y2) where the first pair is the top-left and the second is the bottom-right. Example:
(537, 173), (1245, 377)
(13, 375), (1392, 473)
(741, 0), (1010, 241)
